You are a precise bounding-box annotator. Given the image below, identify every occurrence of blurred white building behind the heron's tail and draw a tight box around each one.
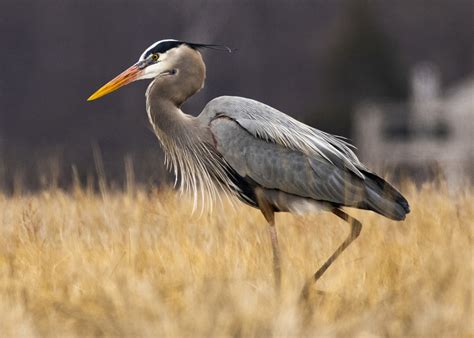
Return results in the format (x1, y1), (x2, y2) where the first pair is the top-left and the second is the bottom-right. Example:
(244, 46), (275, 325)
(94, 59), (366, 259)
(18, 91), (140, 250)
(353, 64), (474, 186)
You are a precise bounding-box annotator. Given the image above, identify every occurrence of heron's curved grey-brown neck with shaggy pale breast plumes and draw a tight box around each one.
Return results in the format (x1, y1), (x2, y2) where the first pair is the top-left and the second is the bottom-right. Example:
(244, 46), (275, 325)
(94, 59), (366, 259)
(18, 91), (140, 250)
(146, 50), (235, 208)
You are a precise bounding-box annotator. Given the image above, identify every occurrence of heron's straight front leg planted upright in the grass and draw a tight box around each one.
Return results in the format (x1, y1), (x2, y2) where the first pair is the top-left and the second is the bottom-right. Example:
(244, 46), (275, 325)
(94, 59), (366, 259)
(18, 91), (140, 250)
(255, 188), (281, 291)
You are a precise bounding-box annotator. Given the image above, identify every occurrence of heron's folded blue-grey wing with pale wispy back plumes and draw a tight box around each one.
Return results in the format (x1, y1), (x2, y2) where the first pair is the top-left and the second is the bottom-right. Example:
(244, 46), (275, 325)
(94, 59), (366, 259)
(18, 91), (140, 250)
(199, 97), (365, 206)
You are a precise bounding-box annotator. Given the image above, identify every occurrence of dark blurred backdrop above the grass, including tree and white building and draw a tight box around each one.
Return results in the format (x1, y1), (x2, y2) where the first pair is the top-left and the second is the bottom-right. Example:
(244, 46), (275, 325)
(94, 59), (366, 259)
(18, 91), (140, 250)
(0, 0), (474, 191)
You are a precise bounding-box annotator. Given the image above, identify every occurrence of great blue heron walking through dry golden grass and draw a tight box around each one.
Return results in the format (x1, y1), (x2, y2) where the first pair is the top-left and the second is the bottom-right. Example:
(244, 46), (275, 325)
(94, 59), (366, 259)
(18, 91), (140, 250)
(88, 39), (410, 293)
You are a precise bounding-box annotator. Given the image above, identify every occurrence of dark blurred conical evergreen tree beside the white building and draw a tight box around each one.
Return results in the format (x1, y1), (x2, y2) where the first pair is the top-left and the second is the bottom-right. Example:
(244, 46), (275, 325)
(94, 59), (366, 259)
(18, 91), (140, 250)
(319, 1), (409, 135)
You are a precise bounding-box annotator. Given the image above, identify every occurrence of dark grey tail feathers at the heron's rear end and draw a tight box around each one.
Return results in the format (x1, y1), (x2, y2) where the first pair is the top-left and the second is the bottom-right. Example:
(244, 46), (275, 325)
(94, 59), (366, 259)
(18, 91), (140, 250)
(363, 171), (410, 221)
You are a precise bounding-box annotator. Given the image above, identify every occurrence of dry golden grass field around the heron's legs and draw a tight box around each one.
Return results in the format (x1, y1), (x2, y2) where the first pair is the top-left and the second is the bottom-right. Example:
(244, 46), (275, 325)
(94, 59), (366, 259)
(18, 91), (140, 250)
(0, 184), (474, 337)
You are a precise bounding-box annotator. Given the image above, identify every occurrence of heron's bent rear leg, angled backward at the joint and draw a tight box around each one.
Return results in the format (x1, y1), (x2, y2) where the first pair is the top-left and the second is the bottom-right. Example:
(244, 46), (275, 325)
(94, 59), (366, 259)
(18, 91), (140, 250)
(301, 209), (362, 299)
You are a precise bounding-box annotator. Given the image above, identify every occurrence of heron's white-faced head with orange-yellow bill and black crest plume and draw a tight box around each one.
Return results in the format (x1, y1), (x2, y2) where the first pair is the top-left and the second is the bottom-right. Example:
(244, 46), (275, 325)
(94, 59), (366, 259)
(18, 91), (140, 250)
(87, 39), (231, 101)
